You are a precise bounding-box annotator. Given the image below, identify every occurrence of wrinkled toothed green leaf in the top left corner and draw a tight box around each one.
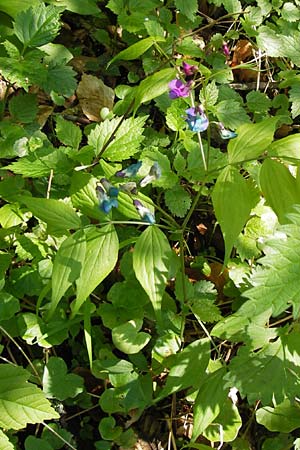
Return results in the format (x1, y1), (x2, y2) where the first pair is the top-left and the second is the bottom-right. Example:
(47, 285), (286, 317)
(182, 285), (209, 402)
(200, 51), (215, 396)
(14, 3), (61, 47)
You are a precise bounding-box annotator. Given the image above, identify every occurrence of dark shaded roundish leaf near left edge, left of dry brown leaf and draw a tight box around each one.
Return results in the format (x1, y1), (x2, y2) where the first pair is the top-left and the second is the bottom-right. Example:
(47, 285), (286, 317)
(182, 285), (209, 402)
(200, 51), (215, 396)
(9, 93), (38, 123)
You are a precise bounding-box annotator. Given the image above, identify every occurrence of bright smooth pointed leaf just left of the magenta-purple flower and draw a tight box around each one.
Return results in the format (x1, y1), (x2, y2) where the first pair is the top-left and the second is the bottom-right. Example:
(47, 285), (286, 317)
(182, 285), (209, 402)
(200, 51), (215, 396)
(134, 69), (176, 111)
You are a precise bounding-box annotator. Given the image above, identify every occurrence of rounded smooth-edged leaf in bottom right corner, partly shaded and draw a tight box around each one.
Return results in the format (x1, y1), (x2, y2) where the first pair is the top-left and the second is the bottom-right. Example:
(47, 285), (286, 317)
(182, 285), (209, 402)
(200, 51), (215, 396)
(256, 399), (300, 433)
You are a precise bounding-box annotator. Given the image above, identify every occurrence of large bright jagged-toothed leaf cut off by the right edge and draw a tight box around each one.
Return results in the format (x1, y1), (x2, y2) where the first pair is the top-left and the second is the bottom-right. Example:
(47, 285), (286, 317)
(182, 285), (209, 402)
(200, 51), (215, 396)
(243, 205), (300, 317)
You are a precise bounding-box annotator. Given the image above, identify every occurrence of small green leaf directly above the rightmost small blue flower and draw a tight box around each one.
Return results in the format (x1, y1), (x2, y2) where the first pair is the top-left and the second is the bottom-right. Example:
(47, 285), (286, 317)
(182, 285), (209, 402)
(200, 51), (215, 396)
(215, 100), (250, 130)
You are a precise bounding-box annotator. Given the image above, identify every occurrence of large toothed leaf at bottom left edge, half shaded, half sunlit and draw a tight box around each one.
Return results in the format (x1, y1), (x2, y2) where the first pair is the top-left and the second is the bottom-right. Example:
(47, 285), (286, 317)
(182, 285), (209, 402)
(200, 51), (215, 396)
(0, 364), (59, 430)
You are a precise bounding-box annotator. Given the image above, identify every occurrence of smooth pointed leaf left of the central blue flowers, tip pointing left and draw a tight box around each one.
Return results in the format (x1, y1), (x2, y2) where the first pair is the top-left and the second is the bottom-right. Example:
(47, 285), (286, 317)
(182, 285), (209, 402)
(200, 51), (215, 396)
(20, 196), (81, 235)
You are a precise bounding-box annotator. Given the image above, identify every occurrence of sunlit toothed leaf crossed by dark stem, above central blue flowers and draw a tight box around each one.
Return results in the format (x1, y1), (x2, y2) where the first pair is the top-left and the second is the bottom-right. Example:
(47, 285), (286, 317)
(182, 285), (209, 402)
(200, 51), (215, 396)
(88, 117), (147, 161)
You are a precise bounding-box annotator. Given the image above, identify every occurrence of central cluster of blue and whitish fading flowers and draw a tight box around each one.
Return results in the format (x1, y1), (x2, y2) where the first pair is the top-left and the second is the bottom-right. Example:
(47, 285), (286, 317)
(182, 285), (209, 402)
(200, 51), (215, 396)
(96, 161), (161, 225)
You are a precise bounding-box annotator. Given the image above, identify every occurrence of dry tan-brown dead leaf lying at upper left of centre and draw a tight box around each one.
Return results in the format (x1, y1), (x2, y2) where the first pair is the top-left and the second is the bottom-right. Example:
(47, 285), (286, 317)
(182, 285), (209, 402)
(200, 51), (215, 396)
(76, 74), (115, 122)
